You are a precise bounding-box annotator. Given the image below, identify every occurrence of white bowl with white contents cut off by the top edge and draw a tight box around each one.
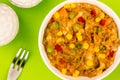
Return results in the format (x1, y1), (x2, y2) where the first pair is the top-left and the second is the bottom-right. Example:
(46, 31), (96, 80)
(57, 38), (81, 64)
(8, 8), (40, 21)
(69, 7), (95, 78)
(10, 0), (41, 8)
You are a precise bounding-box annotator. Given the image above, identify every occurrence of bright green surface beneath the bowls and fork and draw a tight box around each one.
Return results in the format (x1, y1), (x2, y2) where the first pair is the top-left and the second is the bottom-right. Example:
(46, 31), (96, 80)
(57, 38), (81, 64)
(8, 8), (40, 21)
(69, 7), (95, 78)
(0, 0), (120, 80)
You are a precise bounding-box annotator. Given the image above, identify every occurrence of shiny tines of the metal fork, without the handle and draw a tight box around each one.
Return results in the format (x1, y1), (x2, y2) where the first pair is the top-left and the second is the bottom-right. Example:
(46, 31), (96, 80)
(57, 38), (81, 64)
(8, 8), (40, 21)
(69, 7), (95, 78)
(12, 48), (29, 69)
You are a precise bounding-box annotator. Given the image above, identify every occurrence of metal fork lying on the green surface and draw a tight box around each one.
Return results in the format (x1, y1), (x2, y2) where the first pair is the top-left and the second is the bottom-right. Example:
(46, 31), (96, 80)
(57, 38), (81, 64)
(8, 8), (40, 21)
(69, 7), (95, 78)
(7, 48), (29, 80)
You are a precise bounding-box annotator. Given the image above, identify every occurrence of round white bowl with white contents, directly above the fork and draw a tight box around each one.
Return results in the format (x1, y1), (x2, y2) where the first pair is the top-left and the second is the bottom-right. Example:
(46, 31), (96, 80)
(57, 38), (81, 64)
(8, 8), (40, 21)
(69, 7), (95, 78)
(0, 3), (19, 46)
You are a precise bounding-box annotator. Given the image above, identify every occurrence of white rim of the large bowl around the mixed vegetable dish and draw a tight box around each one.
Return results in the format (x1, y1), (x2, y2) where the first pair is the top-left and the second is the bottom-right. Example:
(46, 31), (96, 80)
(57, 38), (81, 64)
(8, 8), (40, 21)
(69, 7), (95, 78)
(38, 0), (120, 80)
